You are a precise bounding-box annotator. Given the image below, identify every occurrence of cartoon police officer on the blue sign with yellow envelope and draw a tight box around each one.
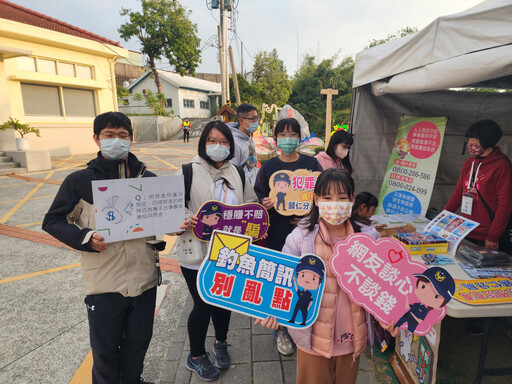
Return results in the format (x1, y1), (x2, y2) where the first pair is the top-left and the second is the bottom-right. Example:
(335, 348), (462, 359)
(288, 255), (325, 325)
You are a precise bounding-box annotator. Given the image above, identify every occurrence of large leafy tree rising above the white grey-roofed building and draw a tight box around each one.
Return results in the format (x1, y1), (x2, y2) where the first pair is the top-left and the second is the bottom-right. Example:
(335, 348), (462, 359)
(118, 0), (201, 93)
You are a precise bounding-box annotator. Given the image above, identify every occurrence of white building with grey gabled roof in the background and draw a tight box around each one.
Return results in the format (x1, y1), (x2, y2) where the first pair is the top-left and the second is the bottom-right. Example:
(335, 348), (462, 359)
(124, 70), (221, 118)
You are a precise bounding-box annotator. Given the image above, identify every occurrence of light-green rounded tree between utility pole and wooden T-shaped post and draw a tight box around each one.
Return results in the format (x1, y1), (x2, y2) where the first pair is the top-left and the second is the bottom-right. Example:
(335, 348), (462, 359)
(252, 49), (292, 106)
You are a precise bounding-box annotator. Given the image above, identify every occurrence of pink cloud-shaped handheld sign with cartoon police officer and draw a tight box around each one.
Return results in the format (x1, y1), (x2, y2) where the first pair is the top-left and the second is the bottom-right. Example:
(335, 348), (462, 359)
(330, 233), (455, 335)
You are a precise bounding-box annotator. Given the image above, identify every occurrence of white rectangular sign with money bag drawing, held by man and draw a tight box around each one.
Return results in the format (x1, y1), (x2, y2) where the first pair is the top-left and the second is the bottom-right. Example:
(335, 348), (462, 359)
(92, 176), (185, 243)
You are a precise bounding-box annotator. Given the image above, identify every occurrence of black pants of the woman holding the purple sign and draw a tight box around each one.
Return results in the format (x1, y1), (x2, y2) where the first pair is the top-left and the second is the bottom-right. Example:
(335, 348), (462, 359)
(181, 267), (231, 357)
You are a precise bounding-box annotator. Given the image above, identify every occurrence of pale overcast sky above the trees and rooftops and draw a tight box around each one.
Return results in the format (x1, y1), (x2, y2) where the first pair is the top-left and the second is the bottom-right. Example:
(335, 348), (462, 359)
(11, 0), (482, 75)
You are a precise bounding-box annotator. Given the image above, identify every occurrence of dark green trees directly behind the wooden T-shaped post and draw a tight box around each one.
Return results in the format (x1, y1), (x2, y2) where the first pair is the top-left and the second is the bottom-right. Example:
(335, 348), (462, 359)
(289, 55), (354, 137)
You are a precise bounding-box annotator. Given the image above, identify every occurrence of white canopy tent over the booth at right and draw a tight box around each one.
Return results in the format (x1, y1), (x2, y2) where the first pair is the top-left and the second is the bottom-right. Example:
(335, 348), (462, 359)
(351, 0), (512, 209)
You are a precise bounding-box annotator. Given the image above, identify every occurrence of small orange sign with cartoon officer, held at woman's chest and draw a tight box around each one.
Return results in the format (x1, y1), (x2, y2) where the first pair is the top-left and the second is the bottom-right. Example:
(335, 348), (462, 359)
(269, 169), (320, 216)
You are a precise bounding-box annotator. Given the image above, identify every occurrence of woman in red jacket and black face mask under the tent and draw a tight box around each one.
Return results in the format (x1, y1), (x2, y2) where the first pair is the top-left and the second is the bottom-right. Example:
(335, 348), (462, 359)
(444, 120), (512, 251)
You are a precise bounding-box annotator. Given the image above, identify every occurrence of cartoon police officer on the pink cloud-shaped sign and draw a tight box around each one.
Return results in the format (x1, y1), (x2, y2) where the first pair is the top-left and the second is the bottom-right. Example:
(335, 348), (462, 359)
(395, 267), (455, 333)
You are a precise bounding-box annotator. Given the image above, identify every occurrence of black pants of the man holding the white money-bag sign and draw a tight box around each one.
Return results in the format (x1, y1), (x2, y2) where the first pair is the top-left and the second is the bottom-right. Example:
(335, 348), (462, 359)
(84, 287), (156, 384)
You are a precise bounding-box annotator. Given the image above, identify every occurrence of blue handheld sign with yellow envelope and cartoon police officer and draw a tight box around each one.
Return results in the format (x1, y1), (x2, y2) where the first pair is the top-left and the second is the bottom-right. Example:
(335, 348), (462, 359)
(197, 230), (325, 328)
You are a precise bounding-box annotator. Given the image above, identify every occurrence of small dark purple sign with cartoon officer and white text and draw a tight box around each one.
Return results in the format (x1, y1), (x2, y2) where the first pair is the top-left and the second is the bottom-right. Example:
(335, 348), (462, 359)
(194, 201), (270, 241)
